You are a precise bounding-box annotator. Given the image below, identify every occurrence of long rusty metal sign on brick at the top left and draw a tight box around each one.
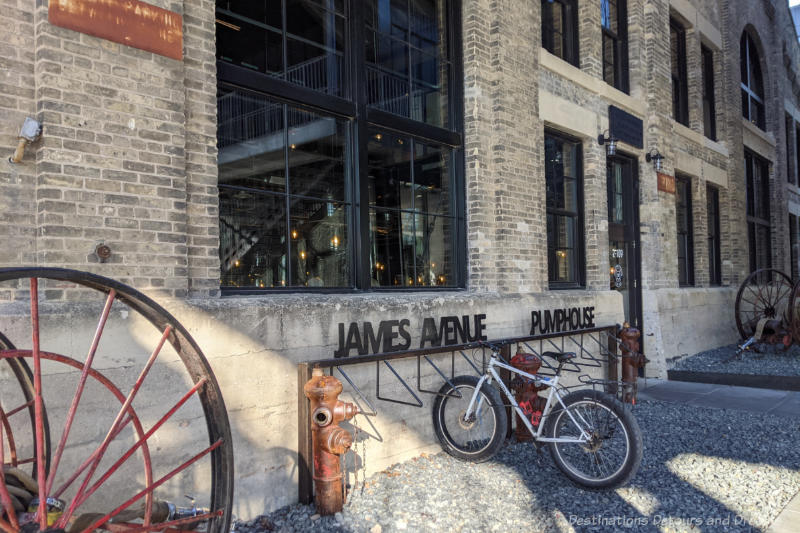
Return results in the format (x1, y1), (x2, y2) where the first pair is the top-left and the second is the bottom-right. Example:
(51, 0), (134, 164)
(48, 0), (183, 59)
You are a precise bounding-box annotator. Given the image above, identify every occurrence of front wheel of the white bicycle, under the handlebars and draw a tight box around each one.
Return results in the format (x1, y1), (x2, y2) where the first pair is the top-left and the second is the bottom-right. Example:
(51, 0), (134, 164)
(433, 376), (508, 463)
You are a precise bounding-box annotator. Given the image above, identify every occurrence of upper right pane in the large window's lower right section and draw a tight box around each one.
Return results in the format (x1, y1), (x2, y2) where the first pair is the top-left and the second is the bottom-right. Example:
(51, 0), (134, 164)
(414, 142), (451, 215)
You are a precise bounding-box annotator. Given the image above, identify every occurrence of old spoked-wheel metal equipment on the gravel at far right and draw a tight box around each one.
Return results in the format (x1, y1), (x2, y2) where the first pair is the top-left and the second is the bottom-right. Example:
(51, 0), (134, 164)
(734, 268), (800, 357)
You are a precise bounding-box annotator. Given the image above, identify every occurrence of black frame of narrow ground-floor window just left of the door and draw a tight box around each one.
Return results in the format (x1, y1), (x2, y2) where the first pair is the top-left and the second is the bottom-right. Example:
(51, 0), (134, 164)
(544, 128), (586, 290)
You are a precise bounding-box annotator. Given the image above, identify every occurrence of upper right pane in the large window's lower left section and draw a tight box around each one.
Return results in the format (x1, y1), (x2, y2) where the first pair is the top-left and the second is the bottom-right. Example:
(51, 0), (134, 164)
(289, 107), (348, 200)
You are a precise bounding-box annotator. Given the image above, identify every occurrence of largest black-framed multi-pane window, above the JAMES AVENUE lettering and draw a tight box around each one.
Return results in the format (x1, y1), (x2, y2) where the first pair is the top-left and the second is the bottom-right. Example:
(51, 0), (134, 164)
(217, 0), (466, 292)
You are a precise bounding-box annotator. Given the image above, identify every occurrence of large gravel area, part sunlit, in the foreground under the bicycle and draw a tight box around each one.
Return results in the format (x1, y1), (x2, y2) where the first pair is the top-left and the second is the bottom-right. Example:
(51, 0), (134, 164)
(235, 401), (800, 533)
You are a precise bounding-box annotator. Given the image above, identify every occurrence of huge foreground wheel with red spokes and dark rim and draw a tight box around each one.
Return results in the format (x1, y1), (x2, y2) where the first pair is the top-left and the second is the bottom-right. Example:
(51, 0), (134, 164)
(0, 268), (233, 533)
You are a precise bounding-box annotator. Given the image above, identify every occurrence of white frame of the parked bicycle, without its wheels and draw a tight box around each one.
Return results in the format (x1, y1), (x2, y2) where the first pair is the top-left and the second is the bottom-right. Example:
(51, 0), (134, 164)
(464, 352), (591, 444)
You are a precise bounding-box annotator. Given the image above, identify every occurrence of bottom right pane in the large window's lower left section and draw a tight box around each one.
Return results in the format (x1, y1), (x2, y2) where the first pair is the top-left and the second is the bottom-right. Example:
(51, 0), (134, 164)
(289, 199), (350, 287)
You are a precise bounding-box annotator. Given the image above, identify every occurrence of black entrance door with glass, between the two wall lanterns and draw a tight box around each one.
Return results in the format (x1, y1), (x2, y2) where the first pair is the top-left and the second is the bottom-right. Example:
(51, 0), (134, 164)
(607, 156), (644, 334)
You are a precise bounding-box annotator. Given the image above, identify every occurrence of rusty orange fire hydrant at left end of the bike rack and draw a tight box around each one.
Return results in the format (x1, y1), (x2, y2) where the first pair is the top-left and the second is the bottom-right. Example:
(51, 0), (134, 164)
(303, 368), (358, 515)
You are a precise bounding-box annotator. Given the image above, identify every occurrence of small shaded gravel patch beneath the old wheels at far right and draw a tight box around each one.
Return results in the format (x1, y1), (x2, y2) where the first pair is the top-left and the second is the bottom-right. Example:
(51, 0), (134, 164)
(671, 344), (800, 376)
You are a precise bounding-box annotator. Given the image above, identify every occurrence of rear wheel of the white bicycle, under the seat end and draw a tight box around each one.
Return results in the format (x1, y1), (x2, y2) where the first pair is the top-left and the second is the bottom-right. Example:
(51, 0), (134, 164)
(545, 391), (643, 489)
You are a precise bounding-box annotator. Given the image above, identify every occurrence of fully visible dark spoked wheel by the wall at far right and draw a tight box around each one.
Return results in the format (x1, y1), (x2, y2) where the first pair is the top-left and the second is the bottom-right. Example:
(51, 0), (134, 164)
(736, 268), (793, 339)
